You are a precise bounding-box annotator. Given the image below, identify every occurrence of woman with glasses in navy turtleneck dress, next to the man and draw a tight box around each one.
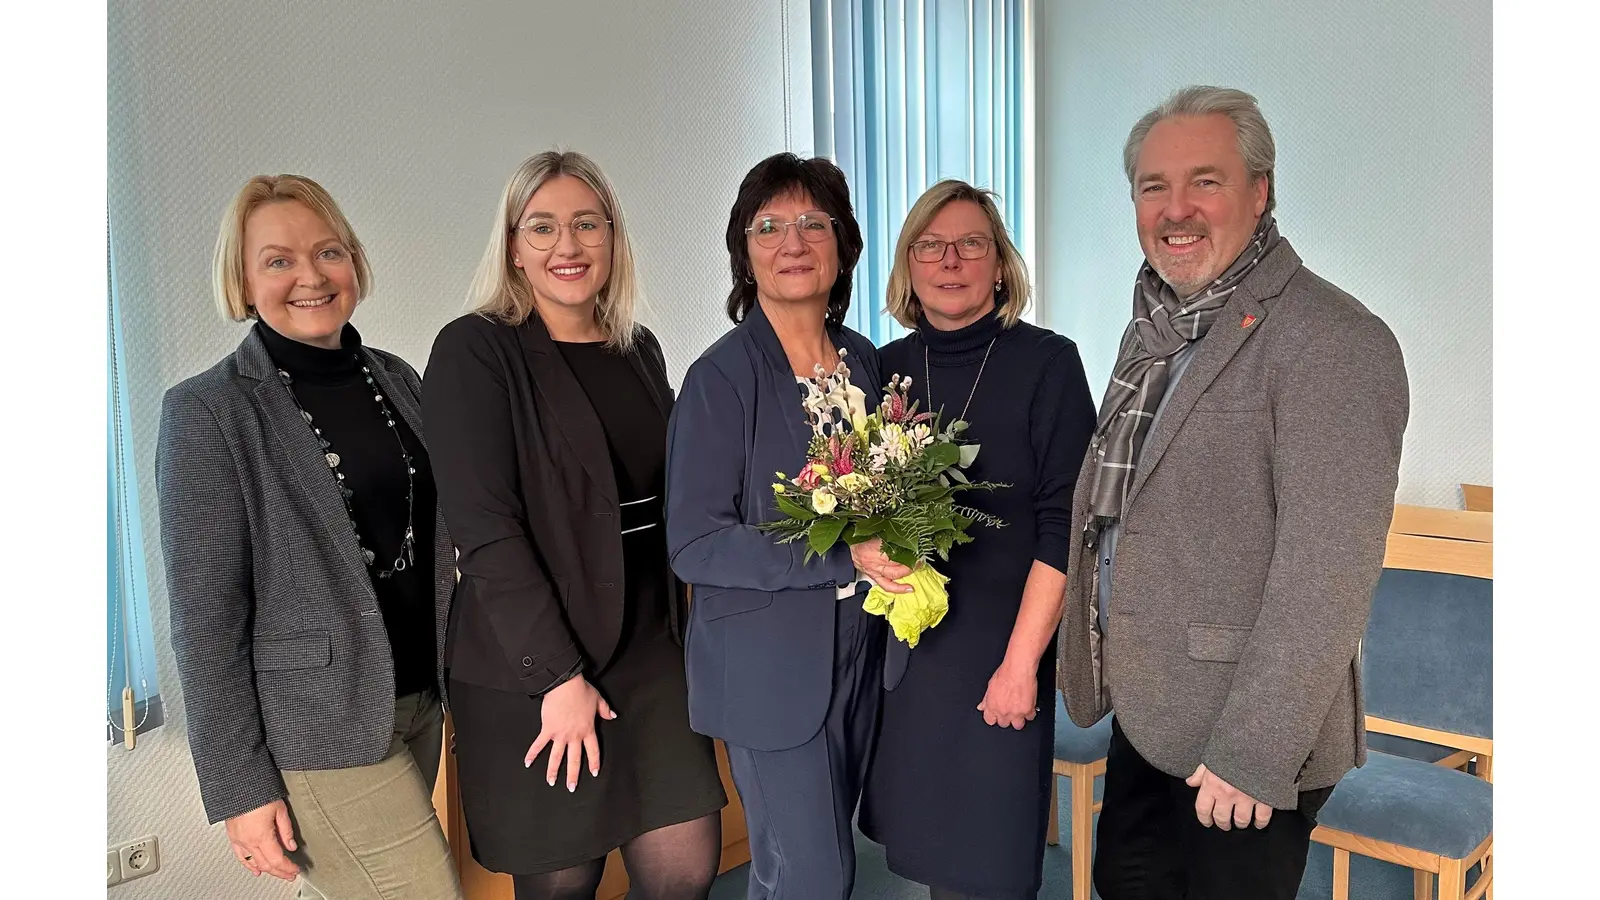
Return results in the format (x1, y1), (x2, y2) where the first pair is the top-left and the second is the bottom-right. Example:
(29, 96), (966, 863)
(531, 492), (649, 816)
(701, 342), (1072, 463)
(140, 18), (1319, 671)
(861, 181), (1094, 900)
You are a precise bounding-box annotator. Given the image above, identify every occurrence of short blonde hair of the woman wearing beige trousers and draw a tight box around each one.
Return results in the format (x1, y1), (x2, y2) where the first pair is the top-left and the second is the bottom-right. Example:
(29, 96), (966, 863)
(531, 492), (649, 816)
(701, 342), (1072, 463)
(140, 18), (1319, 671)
(211, 175), (373, 322)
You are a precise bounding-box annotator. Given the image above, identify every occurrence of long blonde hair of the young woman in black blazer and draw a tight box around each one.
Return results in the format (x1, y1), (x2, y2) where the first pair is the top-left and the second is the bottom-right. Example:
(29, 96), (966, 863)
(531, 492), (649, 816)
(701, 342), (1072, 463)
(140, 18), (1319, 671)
(467, 151), (638, 351)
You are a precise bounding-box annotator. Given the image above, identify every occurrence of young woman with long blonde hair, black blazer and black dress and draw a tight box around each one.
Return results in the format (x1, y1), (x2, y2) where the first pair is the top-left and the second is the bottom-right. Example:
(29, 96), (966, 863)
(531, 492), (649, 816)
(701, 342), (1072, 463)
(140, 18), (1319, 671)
(422, 151), (726, 900)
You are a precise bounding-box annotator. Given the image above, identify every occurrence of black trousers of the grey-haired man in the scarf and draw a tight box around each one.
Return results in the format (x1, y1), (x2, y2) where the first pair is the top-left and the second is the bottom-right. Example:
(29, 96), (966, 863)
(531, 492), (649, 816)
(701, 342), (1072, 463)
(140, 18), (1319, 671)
(1094, 717), (1333, 900)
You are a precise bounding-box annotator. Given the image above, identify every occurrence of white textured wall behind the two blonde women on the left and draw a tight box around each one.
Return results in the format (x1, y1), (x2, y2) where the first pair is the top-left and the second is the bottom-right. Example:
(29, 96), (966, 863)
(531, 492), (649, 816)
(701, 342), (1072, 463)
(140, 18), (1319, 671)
(106, 0), (811, 900)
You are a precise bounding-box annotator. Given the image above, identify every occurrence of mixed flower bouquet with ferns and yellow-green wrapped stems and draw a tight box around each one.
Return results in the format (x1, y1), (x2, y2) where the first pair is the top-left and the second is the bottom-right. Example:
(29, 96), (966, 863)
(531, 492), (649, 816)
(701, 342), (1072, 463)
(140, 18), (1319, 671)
(762, 351), (1006, 647)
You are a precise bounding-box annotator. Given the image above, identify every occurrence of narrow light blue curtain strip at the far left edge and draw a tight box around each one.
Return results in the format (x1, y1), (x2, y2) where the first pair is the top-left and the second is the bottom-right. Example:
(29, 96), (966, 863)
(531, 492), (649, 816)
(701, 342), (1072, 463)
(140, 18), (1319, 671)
(106, 227), (160, 723)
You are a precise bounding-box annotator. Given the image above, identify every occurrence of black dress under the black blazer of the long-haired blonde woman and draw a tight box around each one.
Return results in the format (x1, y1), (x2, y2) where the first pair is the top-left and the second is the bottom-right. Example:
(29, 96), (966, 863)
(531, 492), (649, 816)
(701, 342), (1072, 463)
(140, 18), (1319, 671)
(450, 343), (728, 874)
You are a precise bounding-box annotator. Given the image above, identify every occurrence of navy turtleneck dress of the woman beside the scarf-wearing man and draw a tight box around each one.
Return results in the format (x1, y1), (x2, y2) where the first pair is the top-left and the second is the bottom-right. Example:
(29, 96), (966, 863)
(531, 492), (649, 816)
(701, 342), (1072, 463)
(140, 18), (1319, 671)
(861, 314), (1094, 900)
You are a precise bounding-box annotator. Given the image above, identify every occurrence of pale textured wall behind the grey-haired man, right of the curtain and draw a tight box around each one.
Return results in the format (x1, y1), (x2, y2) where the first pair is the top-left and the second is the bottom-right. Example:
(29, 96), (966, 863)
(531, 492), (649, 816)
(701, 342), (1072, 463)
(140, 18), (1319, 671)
(1037, 0), (1491, 506)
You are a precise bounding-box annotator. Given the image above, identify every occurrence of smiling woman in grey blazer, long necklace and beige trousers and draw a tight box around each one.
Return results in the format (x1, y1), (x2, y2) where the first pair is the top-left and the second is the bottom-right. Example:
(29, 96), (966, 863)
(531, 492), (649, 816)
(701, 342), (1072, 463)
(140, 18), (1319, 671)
(157, 175), (461, 900)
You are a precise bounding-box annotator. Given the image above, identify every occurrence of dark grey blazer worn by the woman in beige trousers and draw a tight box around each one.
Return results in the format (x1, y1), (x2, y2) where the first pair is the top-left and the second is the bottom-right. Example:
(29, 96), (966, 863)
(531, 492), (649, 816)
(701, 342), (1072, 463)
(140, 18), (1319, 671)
(155, 330), (456, 823)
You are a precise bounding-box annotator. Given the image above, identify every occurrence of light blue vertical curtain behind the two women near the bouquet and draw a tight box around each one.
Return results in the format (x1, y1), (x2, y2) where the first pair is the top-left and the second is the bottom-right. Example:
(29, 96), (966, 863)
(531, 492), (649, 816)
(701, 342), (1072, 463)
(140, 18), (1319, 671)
(811, 0), (1030, 346)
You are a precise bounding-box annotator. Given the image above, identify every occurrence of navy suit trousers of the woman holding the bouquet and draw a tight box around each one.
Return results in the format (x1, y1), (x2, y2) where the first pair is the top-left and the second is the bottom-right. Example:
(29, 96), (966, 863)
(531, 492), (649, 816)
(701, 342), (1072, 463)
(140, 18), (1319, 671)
(726, 596), (885, 900)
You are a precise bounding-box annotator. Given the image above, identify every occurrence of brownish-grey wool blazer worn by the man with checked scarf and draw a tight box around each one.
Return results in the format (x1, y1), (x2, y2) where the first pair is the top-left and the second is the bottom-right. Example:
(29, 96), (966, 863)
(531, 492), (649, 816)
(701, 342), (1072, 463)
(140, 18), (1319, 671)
(1058, 240), (1410, 809)
